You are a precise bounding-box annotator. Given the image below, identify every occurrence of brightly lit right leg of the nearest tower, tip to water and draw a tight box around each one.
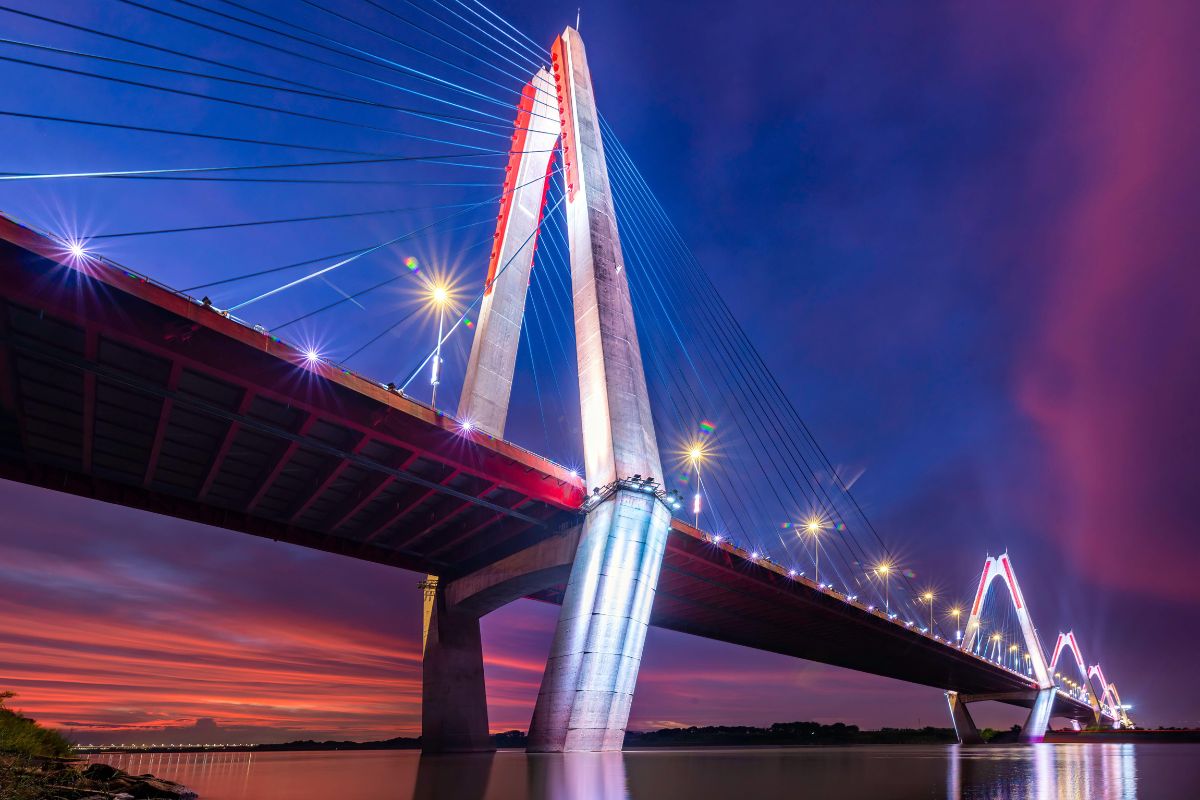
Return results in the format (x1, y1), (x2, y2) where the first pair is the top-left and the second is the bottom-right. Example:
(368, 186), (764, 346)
(529, 28), (671, 752)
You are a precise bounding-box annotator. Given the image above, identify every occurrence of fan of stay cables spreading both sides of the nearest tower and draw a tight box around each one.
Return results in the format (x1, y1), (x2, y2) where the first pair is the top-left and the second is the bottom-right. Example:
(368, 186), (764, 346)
(0, 0), (1003, 638)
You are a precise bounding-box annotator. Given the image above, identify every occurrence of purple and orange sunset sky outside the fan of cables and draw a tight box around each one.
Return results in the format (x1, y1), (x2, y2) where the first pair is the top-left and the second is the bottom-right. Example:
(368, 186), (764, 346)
(0, 0), (1200, 740)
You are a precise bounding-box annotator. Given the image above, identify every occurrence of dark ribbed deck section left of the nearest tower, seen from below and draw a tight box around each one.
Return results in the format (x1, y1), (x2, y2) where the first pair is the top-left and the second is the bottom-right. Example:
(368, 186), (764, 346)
(0, 212), (583, 575)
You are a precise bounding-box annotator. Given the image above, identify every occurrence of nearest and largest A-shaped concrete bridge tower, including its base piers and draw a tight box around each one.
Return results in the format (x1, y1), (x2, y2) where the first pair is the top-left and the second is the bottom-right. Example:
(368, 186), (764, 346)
(422, 28), (671, 752)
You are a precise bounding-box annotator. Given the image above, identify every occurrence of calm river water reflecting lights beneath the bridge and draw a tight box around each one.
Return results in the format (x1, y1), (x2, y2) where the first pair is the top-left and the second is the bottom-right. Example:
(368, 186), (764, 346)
(94, 745), (1200, 800)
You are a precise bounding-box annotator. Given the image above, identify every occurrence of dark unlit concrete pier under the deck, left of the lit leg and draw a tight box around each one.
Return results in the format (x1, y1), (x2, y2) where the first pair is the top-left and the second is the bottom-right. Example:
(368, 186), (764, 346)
(421, 585), (496, 753)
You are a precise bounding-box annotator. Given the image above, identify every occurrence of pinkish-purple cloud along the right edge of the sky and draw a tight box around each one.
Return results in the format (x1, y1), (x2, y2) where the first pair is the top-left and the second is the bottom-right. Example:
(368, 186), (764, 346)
(1019, 2), (1200, 600)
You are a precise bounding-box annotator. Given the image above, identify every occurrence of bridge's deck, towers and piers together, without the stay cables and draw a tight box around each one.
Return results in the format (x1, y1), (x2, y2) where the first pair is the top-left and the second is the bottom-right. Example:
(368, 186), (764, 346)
(0, 20), (1128, 752)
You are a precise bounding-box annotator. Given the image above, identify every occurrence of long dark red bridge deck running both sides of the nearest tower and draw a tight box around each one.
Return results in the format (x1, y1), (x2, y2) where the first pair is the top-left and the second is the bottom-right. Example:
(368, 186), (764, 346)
(0, 216), (1093, 723)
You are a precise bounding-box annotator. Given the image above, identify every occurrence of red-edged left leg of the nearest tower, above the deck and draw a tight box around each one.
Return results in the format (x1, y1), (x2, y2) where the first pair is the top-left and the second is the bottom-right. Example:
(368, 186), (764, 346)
(458, 70), (559, 437)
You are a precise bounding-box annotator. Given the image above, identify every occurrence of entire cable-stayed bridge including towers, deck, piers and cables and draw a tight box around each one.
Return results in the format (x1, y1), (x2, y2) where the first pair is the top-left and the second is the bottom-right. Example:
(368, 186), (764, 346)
(0, 0), (1129, 751)
